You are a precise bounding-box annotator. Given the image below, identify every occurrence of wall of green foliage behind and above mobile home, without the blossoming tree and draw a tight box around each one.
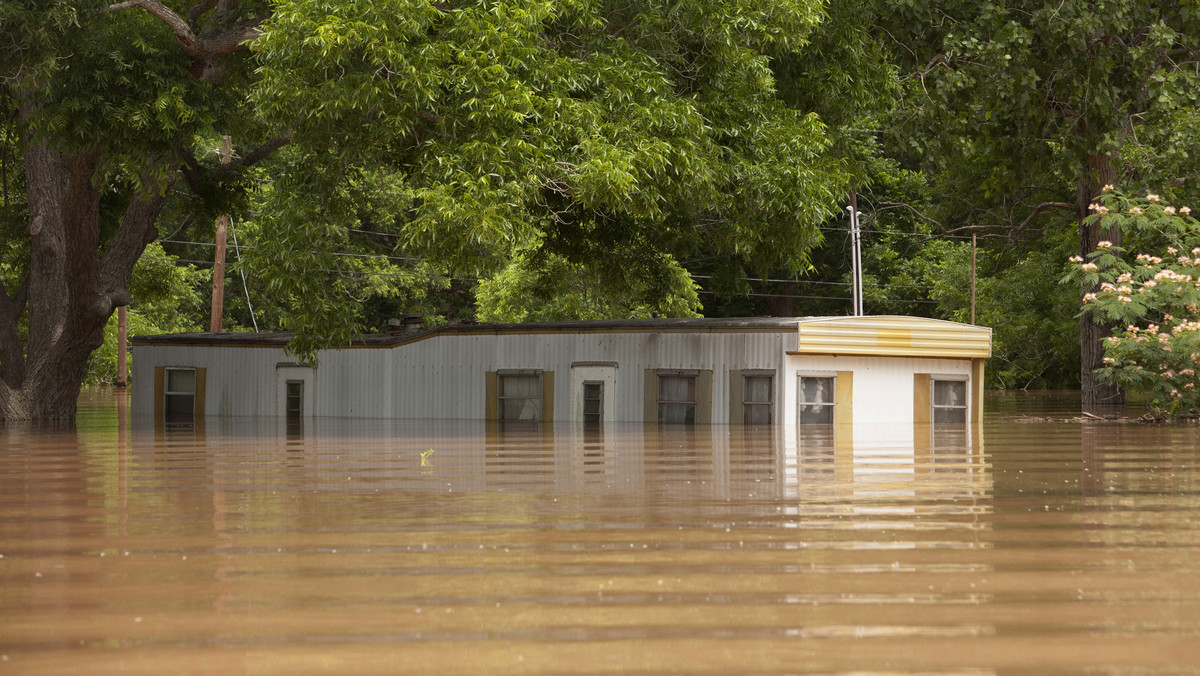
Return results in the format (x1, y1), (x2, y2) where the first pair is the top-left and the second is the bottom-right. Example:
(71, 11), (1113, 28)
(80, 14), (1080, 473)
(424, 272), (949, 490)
(0, 0), (1200, 396)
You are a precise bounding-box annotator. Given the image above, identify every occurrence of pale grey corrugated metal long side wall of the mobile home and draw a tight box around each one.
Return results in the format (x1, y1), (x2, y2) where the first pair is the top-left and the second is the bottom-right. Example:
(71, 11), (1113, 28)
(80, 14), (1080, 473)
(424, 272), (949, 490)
(133, 331), (796, 420)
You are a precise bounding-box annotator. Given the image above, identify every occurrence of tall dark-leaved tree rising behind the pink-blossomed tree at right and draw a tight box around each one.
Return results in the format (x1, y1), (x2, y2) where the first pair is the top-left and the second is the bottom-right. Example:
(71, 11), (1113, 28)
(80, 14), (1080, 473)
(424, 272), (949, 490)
(877, 0), (1200, 406)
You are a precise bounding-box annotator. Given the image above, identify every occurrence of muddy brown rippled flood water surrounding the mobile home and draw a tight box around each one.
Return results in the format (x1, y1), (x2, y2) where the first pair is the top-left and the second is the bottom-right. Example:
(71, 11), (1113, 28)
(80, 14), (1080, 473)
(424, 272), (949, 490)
(0, 393), (1200, 674)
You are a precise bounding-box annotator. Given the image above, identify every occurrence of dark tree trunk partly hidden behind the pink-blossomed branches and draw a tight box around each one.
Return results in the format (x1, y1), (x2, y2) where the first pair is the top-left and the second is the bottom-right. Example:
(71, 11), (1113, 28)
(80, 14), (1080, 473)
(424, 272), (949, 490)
(1075, 155), (1124, 411)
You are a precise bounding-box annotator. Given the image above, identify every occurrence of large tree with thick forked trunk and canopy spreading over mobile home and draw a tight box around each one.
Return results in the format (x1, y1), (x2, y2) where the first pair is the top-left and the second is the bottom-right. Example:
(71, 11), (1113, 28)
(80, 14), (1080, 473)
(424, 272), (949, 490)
(0, 0), (847, 419)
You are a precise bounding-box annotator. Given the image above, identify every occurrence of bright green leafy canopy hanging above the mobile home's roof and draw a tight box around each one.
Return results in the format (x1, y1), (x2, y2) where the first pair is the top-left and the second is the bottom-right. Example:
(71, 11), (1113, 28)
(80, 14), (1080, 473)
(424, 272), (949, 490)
(253, 0), (847, 351)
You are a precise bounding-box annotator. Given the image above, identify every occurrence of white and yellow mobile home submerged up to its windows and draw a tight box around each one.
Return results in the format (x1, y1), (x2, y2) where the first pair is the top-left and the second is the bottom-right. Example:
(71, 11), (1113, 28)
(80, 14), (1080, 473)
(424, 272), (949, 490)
(133, 316), (991, 425)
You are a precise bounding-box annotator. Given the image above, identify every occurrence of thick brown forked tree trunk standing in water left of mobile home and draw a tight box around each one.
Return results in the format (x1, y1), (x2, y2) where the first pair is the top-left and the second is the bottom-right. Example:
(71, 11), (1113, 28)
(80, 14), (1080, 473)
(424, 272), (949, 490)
(0, 121), (174, 421)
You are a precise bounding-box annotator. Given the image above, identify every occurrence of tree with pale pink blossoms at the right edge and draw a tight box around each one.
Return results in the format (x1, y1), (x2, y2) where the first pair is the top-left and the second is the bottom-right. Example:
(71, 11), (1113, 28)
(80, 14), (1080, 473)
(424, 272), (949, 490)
(1067, 186), (1200, 417)
